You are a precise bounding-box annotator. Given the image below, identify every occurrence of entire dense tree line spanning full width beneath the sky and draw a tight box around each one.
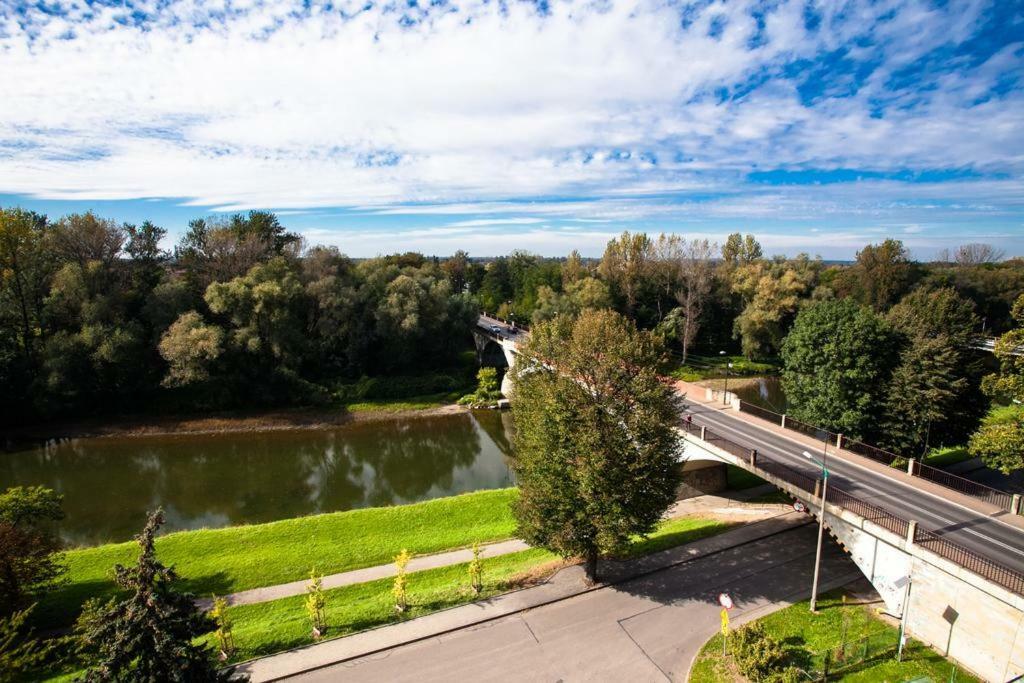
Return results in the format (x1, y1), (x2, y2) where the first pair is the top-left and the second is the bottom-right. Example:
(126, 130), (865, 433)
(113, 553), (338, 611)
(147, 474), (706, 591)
(0, 202), (1024, 450)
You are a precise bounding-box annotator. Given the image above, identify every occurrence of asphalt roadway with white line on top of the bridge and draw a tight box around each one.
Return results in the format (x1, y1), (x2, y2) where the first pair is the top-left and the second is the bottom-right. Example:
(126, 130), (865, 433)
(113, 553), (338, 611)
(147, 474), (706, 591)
(675, 403), (1024, 571)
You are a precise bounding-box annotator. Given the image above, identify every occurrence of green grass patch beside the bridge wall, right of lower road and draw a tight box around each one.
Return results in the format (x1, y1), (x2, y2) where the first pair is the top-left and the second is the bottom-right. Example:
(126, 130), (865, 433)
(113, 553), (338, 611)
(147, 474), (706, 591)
(689, 591), (977, 683)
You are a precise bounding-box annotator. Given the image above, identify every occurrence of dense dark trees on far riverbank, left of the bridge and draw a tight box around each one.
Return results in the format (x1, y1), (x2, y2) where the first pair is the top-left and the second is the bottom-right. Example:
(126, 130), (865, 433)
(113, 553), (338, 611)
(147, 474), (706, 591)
(0, 209), (476, 423)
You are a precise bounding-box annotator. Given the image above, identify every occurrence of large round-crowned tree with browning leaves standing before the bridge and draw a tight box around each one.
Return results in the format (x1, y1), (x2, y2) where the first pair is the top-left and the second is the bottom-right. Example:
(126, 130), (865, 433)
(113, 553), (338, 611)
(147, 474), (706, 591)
(512, 310), (680, 580)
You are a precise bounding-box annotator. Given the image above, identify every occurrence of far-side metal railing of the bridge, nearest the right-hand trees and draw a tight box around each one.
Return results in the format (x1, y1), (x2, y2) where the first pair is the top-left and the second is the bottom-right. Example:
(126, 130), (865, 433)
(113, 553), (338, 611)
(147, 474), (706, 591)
(739, 400), (1017, 512)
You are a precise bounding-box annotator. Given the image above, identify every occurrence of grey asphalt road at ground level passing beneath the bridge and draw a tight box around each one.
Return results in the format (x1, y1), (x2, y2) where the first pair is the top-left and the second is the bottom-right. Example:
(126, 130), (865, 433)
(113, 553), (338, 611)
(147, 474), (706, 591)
(290, 524), (859, 683)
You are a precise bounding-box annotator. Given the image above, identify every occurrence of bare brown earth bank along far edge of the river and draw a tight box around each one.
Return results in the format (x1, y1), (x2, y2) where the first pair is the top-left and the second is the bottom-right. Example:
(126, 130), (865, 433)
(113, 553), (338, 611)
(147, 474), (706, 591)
(7, 393), (469, 441)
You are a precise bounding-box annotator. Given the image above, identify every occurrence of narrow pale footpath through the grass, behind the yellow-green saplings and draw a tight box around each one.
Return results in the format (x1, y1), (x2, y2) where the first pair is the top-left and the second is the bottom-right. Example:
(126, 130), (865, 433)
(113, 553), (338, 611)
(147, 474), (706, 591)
(196, 491), (786, 609)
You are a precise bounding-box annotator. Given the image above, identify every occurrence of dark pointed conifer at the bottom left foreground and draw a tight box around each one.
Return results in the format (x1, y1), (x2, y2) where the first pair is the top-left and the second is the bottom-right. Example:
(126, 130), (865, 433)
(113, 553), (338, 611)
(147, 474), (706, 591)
(79, 510), (246, 683)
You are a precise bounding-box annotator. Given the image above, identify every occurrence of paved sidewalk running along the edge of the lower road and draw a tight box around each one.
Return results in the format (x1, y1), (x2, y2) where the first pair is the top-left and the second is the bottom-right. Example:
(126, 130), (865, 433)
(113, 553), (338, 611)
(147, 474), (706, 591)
(239, 512), (823, 681)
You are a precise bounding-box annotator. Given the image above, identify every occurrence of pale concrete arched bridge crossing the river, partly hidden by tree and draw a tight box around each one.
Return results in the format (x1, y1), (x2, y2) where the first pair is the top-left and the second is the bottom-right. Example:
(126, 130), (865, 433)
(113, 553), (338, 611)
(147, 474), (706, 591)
(474, 316), (1024, 681)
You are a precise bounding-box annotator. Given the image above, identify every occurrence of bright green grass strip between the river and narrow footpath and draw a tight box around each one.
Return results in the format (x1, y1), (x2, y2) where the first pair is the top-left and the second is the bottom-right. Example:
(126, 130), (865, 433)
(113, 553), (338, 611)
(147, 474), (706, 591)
(37, 488), (518, 628)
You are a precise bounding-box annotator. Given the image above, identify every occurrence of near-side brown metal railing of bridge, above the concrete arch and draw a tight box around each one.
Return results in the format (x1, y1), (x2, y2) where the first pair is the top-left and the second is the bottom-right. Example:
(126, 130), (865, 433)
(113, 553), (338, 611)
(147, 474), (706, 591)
(682, 411), (1024, 595)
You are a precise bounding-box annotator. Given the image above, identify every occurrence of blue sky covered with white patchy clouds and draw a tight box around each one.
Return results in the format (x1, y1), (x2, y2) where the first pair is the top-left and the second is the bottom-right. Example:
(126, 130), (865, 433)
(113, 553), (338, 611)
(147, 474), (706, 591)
(0, 0), (1024, 258)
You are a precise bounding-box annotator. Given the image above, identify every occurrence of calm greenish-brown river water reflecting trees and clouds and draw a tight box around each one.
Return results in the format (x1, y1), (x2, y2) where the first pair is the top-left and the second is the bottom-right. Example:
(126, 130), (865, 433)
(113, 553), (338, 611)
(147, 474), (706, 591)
(0, 411), (513, 545)
